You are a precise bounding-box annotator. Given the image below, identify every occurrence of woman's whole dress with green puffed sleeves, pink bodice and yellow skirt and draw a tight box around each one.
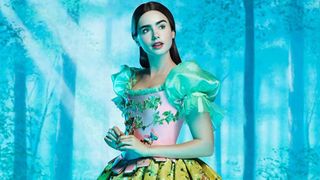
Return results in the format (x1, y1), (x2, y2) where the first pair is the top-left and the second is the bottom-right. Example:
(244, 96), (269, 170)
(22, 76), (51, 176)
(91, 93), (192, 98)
(98, 61), (223, 179)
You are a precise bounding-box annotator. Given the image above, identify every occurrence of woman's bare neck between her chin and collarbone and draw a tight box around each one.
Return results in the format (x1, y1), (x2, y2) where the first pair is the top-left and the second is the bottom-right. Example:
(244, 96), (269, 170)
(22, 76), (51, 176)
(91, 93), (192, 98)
(148, 51), (175, 78)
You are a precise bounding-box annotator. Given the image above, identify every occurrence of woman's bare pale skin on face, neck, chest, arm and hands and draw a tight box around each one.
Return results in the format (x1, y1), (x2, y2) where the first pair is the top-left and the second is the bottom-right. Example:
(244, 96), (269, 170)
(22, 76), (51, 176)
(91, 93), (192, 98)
(105, 11), (214, 158)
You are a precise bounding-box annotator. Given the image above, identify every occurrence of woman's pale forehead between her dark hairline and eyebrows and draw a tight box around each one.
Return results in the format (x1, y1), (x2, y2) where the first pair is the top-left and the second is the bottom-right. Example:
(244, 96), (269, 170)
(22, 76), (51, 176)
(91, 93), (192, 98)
(138, 10), (168, 27)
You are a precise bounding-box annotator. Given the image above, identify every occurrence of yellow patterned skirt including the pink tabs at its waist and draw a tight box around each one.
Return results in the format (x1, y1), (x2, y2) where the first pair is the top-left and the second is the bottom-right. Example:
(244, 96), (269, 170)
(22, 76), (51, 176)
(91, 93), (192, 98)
(98, 154), (222, 180)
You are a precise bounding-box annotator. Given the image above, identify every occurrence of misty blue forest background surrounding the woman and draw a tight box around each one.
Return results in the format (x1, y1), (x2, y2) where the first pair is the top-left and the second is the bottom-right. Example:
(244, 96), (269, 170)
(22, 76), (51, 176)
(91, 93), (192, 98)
(0, 0), (320, 179)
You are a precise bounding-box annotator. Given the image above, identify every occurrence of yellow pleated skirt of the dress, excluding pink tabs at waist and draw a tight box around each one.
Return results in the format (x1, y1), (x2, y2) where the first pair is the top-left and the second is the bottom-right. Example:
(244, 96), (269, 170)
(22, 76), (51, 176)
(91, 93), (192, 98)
(98, 158), (222, 180)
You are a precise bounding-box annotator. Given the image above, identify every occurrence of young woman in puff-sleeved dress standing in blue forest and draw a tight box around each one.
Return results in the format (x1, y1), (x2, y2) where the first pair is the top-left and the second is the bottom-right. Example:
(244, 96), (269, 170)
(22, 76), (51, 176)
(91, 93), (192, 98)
(98, 2), (221, 179)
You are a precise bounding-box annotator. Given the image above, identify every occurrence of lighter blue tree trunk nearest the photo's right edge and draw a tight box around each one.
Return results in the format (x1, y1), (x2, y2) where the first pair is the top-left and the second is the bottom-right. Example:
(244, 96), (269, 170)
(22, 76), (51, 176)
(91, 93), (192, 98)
(288, 0), (309, 179)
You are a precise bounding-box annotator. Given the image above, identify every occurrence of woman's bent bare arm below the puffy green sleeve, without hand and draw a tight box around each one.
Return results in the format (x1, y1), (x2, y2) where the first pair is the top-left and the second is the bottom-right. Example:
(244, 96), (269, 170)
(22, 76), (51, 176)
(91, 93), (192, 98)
(146, 113), (213, 158)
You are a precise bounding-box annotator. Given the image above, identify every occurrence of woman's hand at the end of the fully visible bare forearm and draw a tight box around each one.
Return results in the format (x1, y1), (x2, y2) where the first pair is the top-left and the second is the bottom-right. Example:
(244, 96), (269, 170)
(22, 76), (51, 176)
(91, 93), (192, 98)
(119, 135), (149, 157)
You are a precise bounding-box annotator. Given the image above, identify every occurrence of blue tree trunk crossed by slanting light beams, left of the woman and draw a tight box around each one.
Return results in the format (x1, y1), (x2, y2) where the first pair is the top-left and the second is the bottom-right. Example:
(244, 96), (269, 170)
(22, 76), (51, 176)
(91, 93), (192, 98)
(54, 0), (79, 180)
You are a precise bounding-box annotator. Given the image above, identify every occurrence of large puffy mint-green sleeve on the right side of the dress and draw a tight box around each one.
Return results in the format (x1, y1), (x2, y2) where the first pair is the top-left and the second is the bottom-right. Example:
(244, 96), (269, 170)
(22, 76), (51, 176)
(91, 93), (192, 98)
(165, 61), (224, 129)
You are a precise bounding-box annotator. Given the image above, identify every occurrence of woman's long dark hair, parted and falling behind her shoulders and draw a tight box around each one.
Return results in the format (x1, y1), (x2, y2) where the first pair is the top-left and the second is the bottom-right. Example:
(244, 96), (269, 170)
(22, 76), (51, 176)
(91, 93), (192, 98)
(131, 1), (181, 68)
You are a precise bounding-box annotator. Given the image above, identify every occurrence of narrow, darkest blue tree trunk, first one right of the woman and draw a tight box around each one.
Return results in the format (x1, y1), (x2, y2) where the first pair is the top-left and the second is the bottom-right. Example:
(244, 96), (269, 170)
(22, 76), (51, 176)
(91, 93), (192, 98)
(243, 0), (255, 179)
